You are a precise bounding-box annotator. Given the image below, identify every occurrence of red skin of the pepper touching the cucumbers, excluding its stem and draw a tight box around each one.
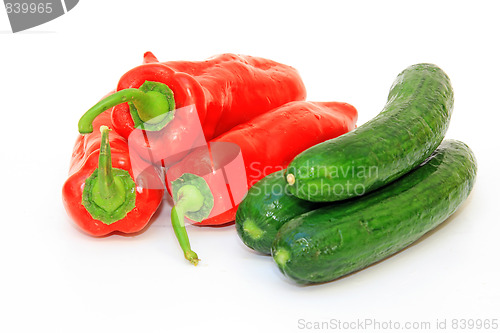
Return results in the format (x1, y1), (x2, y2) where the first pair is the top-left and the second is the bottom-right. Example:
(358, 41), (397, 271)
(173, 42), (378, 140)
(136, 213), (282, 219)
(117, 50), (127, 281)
(166, 101), (357, 226)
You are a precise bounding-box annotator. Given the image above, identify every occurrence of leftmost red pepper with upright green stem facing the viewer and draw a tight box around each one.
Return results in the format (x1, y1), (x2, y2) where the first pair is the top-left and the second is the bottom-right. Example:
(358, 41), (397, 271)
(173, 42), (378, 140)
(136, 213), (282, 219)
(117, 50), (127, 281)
(63, 107), (164, 236)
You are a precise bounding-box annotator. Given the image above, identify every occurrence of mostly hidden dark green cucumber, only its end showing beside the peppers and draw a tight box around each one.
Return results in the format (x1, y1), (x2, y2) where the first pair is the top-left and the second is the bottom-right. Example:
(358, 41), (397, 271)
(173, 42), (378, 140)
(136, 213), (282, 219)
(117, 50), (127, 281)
(236, 170), (324, 254)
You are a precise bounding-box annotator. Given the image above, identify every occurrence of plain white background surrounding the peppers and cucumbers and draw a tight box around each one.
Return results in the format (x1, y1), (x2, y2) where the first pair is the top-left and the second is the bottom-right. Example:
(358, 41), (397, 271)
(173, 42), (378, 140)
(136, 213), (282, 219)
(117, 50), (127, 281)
(0, 0), (500, 332)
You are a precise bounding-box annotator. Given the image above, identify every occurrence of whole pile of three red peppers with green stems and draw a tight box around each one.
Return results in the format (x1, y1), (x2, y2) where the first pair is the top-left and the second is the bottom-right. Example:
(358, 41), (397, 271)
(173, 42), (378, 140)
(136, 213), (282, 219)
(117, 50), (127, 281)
(63, 52), (357, 265)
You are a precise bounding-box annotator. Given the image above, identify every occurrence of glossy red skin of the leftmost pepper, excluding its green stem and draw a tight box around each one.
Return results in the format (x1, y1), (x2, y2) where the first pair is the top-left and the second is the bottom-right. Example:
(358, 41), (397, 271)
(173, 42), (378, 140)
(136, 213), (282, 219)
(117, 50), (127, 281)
(62, 110), (164, 236)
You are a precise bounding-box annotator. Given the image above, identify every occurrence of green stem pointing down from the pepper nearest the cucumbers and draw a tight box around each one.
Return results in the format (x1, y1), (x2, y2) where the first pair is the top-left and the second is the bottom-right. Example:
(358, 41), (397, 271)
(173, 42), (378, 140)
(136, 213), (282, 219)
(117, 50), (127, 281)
(171, 184), (205, 266)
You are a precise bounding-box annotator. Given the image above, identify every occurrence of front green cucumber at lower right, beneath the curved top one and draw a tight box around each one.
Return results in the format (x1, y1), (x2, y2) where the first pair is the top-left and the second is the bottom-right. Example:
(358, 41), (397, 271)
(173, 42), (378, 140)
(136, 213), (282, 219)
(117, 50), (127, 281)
(272, 140), (477, 284)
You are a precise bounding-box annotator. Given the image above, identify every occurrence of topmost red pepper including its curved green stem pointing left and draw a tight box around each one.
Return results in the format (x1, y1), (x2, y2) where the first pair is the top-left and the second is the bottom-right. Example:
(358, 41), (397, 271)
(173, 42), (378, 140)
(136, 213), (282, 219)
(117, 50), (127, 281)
(79, 52), (306, 146)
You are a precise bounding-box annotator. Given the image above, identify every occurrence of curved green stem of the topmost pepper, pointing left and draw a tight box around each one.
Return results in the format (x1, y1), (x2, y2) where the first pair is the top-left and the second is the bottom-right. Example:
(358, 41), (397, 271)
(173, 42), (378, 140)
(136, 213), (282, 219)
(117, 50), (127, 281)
(78, 81), (171, 134)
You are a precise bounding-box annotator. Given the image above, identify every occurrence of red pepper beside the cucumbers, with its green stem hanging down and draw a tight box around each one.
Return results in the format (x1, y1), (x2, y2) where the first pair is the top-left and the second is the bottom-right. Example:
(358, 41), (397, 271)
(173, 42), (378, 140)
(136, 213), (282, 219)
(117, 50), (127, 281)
(166, 102), (357, 263)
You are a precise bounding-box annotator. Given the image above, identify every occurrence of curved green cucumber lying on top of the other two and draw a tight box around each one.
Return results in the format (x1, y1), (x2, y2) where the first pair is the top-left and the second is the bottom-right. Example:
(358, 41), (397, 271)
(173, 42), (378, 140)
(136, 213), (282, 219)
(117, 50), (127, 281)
(287, 64), (453, 201)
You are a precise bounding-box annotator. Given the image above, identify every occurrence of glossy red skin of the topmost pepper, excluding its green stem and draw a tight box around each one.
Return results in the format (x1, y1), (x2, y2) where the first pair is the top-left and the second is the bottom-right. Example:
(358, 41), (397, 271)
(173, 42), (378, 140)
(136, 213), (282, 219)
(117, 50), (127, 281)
(112, 52), (306, 142)
